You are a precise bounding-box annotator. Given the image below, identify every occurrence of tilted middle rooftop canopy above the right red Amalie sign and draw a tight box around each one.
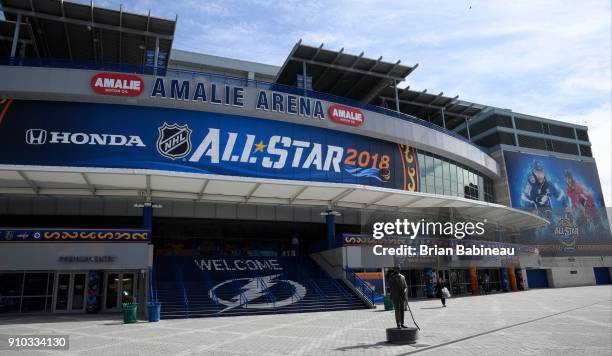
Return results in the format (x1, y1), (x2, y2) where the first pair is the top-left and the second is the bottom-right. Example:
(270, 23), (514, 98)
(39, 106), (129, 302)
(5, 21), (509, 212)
(276, 40), (417, 103)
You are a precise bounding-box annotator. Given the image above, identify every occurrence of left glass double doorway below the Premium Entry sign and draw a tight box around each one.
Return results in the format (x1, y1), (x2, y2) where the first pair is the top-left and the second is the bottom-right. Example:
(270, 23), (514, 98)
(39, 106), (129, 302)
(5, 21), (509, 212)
(53, 272), (87, 313)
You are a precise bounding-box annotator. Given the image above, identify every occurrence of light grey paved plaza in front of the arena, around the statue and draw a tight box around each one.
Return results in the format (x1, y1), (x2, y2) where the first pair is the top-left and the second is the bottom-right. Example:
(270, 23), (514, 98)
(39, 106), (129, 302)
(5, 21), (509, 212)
(0, 286), (612, 356)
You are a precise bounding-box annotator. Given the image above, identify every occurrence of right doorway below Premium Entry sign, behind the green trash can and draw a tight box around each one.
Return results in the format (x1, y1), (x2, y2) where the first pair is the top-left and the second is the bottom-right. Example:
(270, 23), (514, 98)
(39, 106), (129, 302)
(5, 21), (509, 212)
(103, 272), (137, 311)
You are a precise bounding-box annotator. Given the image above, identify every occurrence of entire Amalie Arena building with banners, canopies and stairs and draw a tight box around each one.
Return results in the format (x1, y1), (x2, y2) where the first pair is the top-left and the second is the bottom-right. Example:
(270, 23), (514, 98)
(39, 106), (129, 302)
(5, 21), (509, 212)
(0, 0), (612, 317)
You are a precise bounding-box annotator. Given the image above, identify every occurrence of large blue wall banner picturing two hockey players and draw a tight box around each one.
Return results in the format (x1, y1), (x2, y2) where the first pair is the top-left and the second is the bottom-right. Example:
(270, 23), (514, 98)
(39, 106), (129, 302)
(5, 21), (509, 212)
(504, 151), (612, 256)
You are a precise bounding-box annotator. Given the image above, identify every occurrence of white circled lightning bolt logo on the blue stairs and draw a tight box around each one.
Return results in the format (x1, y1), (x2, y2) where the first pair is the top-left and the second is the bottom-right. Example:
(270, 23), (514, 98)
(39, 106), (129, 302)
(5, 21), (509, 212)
(208, 274), (306, 313)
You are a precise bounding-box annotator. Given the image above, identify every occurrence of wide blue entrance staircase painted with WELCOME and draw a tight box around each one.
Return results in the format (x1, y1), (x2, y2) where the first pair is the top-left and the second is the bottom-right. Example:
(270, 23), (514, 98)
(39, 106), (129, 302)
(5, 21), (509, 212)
(152, 256), (367, 318)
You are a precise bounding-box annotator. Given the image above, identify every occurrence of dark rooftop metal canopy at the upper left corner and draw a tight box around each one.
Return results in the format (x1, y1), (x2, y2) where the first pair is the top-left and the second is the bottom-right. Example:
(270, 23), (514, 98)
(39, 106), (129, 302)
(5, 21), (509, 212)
(0, 0), (176, 65)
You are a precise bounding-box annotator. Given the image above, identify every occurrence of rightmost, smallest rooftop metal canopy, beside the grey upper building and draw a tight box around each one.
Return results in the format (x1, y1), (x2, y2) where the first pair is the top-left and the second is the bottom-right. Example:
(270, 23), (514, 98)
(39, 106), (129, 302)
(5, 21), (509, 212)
(372, 87), (485, 130)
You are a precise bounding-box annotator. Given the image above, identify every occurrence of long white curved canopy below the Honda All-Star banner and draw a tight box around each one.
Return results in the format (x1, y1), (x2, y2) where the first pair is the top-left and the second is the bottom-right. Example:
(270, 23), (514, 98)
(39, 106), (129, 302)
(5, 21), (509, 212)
(0, 166), (548, 230)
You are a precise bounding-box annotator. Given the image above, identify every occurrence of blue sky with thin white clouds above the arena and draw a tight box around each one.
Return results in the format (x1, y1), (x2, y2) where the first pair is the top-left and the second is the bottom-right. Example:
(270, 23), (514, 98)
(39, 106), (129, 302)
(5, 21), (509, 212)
(85, 0), (612, 206)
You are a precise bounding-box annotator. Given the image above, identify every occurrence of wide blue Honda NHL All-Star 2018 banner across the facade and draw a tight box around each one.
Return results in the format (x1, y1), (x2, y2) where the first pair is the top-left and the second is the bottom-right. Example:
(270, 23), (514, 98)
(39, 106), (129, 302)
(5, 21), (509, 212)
(0, 100), (419, 191)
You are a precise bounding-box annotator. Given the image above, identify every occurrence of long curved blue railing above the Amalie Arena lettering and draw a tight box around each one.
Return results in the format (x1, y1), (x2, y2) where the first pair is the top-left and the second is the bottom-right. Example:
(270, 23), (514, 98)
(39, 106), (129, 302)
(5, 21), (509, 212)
(0, 57), (484, 152)
